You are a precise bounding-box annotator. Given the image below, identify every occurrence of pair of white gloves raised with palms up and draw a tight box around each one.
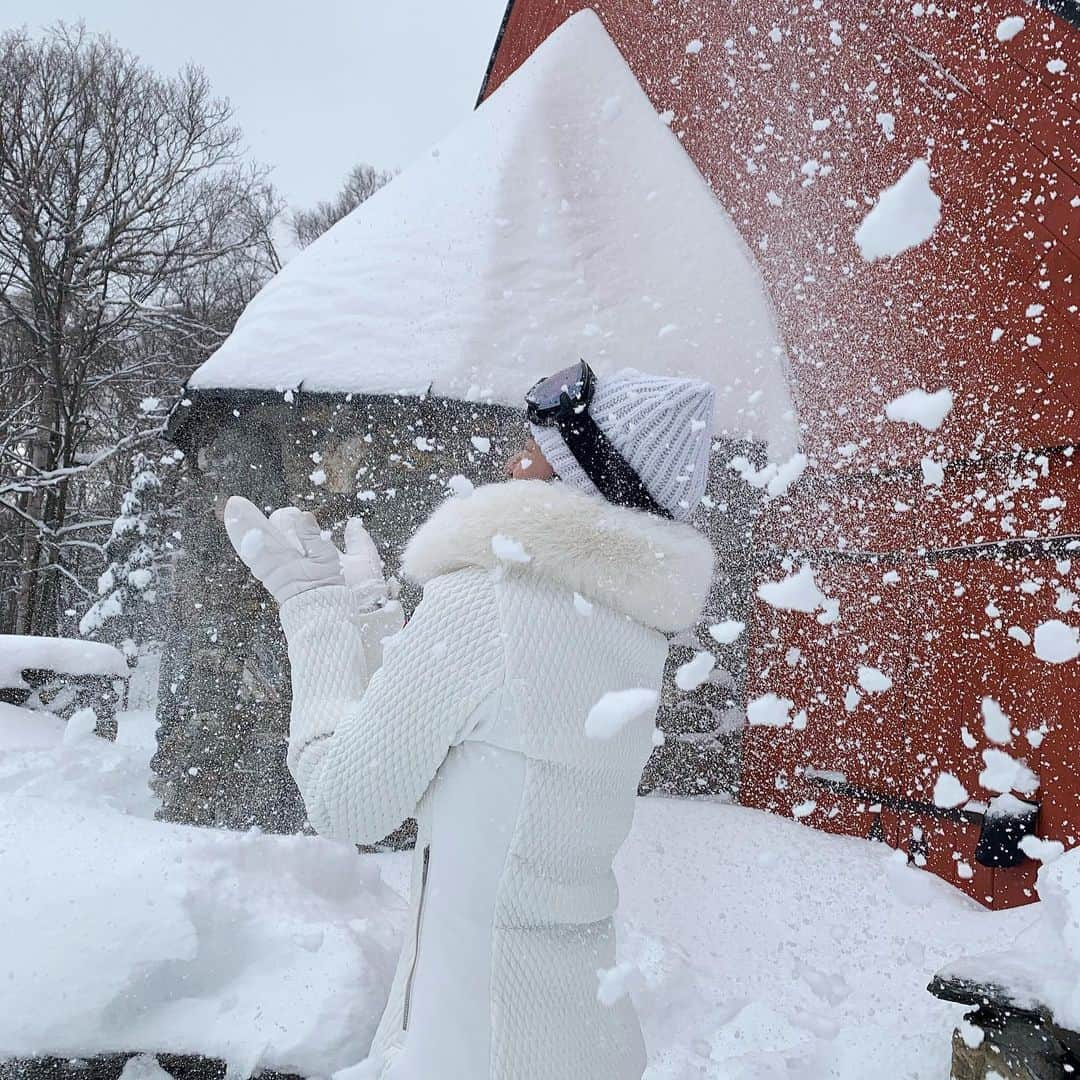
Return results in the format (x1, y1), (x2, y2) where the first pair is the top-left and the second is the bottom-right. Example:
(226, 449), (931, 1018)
(225, 496), (387, 607)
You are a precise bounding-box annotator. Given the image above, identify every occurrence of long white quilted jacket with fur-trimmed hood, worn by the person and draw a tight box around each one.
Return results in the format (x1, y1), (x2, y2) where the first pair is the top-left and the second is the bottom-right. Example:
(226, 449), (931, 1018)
(281, 481), (713, 1080)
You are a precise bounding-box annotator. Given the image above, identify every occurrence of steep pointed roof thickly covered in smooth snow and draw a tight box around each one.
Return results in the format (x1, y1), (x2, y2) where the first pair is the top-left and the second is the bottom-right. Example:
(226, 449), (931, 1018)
(189, 11), (798, 456)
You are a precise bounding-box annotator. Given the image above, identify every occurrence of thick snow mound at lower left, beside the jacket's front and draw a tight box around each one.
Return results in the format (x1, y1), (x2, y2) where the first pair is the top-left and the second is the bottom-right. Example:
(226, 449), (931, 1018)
(0, 790), (405, 1077)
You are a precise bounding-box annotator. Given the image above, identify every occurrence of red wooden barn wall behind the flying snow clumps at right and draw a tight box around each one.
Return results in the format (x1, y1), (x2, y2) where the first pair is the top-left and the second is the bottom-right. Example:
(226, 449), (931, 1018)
(485, 0), (1080, 906)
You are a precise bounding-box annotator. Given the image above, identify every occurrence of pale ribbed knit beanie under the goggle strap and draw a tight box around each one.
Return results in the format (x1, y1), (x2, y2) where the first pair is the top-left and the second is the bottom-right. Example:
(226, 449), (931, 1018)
(529, 367), (716, 522)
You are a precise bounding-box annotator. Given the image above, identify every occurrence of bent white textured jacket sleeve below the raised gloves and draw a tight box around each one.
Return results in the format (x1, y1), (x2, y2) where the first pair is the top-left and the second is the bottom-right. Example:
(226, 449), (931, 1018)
(274, 570), (504, 843)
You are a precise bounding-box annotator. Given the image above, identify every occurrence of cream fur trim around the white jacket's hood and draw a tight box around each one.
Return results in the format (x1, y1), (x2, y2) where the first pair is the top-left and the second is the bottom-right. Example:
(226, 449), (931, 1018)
(402, 481), (713, 633)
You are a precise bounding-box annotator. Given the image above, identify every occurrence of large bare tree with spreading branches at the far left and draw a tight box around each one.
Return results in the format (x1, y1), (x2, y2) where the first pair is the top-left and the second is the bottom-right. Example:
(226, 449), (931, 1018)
(0, 25), (279, 633)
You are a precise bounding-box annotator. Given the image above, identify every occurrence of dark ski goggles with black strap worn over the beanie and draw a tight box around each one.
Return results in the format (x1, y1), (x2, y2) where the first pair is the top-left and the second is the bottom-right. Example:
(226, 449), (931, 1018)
(525, 360), (672, 517)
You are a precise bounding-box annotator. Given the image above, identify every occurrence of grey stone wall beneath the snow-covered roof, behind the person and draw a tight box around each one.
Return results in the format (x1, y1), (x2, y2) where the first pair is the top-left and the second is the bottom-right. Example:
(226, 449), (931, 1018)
(153, 394), (751, 833)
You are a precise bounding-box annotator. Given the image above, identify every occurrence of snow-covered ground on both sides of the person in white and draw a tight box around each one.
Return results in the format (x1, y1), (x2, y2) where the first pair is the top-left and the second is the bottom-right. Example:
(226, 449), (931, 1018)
(0, 706), (1035, 1080)
